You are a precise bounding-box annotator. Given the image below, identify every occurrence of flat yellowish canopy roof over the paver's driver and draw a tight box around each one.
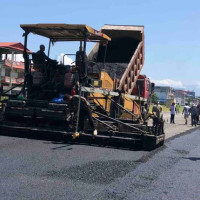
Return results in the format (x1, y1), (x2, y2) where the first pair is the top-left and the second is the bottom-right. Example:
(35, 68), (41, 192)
(20, 24), (111, 41)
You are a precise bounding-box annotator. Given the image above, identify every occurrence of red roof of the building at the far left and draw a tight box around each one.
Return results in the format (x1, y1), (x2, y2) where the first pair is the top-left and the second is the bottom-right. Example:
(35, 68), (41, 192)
(0, 42), (31, 54)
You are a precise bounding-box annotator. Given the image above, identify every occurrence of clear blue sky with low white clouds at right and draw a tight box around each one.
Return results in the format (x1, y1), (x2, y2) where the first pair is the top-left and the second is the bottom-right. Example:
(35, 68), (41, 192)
(0, 0), (200, 96)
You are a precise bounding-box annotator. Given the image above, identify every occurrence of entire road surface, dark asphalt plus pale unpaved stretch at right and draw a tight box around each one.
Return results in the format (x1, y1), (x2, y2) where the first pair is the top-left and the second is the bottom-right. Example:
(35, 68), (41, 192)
(0, 113), (200, 200)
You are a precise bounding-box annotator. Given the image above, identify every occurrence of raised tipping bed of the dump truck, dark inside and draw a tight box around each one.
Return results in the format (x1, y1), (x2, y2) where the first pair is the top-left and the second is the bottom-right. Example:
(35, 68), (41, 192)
(88, 25), (144, 94)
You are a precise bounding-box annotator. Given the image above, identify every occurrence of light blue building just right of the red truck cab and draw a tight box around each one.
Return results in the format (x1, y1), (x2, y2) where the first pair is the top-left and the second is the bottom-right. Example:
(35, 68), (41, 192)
(154, 86), (174, 104)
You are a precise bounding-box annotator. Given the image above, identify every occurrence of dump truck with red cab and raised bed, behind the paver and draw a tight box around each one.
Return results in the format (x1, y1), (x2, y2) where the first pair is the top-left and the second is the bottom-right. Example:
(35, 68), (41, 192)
(88, 25), (154, 117)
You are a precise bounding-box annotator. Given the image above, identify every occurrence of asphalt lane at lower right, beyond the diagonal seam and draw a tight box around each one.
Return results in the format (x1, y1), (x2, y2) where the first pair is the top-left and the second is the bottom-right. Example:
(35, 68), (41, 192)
(91, 129), (200, 200)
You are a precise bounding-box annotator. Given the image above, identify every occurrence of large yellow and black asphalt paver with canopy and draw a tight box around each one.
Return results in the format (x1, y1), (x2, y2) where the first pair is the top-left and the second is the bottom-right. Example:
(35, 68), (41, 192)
(0, 24), (164, 149)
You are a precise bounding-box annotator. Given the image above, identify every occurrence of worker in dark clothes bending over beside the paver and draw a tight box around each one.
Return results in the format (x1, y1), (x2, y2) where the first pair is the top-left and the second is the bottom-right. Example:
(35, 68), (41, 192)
(65, 95), (97, 136)
